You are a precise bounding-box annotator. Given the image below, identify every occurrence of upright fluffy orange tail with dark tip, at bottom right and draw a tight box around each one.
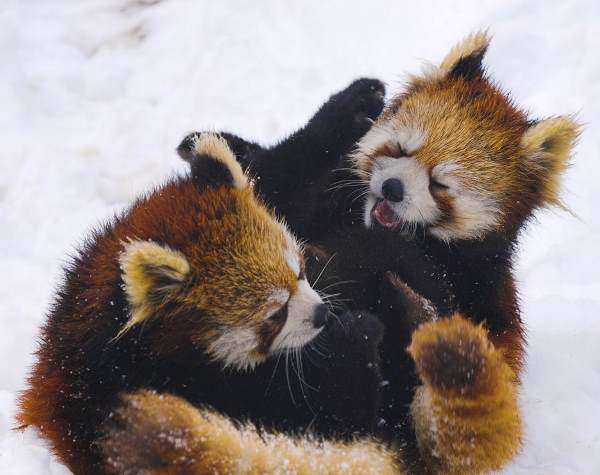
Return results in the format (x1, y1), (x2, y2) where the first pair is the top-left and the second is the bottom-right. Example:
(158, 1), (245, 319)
(409, 314), (522, 475)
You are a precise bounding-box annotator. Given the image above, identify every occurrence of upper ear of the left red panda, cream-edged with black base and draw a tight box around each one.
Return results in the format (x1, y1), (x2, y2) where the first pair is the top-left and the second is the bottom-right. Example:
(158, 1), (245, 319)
(177, 133), (248, 189)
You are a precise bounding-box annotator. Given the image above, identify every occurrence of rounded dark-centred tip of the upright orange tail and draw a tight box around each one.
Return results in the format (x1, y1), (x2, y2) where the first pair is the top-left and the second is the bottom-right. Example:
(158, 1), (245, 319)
(408, 314), (502, 395)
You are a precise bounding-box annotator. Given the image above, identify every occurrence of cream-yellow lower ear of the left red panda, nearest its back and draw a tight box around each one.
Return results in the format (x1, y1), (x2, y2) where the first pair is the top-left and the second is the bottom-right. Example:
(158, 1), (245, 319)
(119, 241), (190, 335)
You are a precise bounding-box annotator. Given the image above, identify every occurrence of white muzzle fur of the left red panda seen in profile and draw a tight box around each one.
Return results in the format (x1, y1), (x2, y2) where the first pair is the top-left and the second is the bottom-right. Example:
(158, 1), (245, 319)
(271, 280), (323, 352)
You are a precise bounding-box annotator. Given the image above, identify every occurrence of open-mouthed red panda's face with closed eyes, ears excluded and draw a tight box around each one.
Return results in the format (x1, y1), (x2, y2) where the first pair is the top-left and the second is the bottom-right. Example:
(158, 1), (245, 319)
(359, 84), (525, 240)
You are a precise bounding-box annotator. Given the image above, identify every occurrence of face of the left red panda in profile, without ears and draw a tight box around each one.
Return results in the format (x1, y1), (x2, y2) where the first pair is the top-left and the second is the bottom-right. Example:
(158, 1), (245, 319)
(194, 197), (329, 369)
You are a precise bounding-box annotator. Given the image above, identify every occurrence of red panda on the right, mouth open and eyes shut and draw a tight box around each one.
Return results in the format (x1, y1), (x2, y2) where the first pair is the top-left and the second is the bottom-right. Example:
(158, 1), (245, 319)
(178, 33), (579, 472)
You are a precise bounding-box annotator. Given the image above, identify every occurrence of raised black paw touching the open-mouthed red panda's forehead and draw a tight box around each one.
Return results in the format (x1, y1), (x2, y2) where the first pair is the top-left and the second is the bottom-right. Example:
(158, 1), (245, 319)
(309, 78), (385, 155)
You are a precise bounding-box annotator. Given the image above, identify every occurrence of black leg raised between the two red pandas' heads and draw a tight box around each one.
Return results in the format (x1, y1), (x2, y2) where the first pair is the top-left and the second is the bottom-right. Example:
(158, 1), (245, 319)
(250, 78), (385, 237)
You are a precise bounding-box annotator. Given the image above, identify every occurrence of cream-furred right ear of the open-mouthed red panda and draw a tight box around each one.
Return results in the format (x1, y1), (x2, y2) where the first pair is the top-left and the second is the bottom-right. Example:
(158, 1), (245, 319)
(521, 116), (581, 206)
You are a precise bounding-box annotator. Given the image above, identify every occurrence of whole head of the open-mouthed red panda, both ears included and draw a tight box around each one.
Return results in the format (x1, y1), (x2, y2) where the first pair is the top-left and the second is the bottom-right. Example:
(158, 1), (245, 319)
(353, 33), (578, 241)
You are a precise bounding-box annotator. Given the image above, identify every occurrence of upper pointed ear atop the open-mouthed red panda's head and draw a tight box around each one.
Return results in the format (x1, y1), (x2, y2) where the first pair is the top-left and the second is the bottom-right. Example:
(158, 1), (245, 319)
(440, 31), (491, 80)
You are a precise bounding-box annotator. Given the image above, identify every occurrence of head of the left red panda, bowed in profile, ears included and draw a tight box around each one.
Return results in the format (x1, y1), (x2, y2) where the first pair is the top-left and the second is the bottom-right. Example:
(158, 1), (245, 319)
(119, 134), (328, 369)
